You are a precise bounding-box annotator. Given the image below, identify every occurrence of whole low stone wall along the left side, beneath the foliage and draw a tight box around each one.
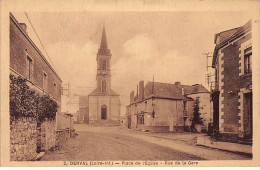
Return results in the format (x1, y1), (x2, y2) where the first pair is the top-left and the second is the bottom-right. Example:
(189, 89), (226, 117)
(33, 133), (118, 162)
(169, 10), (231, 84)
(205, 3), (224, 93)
(10, 115), (75, 161)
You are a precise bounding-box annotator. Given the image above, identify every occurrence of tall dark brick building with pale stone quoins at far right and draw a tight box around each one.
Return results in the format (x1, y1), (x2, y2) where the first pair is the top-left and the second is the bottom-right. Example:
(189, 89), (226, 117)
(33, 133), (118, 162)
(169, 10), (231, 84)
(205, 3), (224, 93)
(212, 21), (253, 142)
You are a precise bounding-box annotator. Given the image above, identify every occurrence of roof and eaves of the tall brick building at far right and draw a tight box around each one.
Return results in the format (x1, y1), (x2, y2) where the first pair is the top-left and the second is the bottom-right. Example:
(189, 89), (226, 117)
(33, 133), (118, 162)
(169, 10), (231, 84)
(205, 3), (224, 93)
(212, 20), (252, 68)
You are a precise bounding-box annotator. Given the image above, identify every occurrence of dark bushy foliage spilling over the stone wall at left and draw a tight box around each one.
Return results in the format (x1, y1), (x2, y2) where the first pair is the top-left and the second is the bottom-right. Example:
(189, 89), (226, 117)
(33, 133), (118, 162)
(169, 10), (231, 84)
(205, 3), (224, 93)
(9, 75), (58, 122)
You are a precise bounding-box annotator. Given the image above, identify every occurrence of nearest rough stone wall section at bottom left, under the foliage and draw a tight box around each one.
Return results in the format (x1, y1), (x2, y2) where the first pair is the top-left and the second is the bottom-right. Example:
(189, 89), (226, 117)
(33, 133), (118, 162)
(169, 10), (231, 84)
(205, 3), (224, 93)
(10, 118), (37, 161)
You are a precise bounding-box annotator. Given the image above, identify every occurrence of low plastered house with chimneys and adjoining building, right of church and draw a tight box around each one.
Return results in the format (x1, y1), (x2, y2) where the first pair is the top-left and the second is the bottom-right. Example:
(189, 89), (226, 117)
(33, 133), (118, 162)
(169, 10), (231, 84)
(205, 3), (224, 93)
(126, 81), (210, 132)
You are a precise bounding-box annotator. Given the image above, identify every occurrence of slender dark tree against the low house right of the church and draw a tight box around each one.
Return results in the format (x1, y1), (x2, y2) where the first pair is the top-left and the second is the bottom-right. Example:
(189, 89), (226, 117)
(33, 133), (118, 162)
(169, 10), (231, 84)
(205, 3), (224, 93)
(191, 99), (203, 132)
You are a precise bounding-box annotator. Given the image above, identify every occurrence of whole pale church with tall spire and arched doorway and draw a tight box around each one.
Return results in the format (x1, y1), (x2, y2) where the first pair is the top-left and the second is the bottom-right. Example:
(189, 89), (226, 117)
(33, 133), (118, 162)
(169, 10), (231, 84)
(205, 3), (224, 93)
(88, 26), (121, 123)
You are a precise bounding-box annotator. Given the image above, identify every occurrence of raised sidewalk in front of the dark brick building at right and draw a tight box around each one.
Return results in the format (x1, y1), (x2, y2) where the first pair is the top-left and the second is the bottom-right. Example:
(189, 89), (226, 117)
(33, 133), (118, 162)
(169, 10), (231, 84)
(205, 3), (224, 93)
(197, 136), (252, 155)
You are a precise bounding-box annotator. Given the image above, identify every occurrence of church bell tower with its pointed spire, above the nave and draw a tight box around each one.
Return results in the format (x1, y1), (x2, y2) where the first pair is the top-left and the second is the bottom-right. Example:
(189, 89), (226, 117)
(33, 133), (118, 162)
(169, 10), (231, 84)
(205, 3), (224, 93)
(96, 26), (112, 95)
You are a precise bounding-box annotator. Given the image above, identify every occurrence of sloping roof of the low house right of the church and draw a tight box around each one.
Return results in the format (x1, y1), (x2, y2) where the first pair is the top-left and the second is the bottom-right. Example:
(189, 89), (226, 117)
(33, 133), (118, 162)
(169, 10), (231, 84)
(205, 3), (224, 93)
(141, 82), (209, 100)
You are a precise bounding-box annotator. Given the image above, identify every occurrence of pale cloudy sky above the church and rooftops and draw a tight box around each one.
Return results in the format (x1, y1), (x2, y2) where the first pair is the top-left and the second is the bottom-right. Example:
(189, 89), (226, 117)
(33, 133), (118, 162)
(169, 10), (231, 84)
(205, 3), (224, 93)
(13, 11), (252, 115)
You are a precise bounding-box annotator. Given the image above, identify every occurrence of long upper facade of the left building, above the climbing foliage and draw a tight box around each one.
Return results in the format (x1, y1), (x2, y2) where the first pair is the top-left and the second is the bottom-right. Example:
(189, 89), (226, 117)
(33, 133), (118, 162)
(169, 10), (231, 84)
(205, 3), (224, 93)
(10, 13), (62, 112)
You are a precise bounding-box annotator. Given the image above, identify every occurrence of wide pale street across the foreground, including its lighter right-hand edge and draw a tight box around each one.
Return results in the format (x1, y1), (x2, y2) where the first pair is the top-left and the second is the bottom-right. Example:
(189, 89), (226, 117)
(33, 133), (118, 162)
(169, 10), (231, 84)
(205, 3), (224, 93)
(41, 125), (252, 161)
